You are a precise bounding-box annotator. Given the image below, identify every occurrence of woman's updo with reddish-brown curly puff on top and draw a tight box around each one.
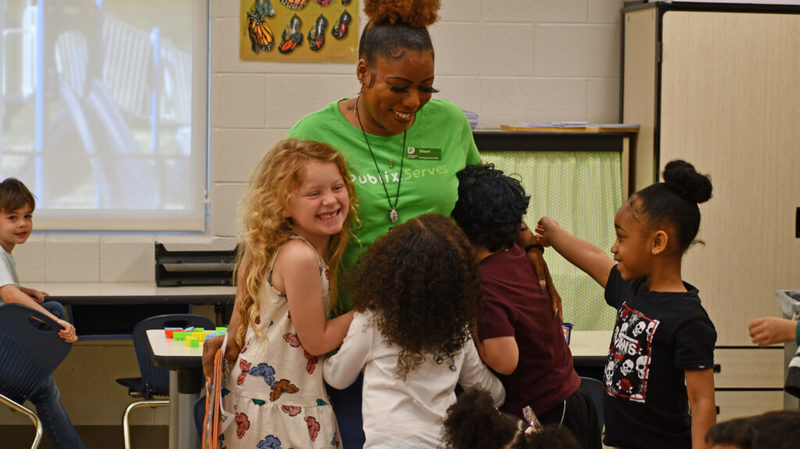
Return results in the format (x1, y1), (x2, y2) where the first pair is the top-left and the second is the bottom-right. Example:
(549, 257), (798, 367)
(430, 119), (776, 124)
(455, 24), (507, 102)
(358, 0), (439, 66)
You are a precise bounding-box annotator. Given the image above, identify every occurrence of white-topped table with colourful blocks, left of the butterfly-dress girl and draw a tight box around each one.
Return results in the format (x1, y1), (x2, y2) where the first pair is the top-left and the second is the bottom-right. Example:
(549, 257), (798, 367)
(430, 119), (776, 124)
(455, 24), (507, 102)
(147, 329), (203, 449)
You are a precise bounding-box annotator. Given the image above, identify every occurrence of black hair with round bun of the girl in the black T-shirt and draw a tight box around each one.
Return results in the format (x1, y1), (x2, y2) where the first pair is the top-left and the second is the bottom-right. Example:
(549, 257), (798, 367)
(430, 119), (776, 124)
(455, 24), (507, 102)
(628, 160), (712, 254)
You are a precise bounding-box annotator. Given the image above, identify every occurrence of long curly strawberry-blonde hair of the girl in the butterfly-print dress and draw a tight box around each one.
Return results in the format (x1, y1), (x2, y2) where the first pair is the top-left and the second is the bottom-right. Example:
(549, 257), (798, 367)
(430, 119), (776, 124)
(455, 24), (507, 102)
(235, 138), (358, 345)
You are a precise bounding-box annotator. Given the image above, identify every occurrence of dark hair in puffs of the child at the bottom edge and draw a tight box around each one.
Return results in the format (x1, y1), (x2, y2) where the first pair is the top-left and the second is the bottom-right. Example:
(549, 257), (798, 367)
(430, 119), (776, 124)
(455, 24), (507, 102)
(442, 389), (581, 449)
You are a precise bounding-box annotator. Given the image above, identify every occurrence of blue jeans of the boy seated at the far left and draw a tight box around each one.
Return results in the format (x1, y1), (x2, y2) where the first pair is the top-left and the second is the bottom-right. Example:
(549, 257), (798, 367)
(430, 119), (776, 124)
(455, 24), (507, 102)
(28, 301), (85, 449)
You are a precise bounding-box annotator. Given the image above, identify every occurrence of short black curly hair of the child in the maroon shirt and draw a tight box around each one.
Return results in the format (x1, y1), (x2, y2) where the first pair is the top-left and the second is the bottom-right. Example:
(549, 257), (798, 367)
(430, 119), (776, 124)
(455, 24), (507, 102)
(452, 164), (531, 252)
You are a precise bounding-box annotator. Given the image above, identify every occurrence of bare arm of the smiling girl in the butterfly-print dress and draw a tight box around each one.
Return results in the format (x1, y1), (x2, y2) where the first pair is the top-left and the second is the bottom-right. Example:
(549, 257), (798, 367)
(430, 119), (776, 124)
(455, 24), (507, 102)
(272, 240), (353, 355)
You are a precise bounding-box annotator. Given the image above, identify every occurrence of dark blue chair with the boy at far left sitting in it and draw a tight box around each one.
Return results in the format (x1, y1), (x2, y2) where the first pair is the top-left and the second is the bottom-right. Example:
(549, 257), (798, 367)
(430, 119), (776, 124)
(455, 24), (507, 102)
(0, 304), (72, 449)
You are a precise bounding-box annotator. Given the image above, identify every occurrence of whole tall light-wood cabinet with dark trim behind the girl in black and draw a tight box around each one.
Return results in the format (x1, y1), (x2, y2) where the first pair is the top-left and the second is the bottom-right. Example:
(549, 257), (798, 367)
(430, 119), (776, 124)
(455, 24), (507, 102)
(623, 2), (800, 420)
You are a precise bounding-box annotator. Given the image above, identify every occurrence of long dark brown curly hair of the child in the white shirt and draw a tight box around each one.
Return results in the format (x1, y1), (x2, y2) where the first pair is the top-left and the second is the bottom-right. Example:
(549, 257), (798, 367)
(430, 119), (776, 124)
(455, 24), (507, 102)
(345, 214), (481, 380)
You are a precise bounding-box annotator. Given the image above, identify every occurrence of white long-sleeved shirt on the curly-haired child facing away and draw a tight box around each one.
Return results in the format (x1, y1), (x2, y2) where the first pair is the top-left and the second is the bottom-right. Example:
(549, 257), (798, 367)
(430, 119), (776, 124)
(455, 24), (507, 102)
(323, 312), (505, 449)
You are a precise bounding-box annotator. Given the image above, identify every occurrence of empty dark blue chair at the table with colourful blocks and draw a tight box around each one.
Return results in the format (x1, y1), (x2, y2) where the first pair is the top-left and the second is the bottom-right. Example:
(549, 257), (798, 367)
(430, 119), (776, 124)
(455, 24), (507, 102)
(117, 313), (214, 449)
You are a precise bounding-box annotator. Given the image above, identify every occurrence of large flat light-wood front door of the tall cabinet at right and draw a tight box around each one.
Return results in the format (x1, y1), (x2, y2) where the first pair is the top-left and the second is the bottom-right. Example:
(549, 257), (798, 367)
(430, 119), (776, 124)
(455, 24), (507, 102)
(659, 11), (800, 346)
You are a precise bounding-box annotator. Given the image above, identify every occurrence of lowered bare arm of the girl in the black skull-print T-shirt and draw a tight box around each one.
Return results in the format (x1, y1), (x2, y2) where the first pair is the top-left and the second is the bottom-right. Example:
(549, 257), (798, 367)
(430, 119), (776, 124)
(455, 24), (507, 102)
(684, 368), (717, 449)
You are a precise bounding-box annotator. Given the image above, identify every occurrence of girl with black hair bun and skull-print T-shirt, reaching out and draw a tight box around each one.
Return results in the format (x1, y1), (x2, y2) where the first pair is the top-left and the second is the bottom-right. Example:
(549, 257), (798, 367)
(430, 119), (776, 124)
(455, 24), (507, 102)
(536, 160), (717, 449)
